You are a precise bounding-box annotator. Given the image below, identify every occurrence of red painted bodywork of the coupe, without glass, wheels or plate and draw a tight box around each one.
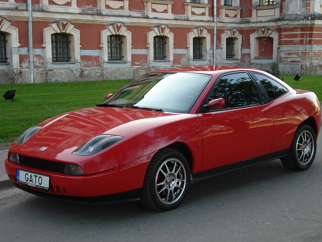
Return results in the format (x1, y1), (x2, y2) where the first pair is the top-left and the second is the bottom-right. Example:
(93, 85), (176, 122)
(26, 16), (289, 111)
(5, 67), (321, 202)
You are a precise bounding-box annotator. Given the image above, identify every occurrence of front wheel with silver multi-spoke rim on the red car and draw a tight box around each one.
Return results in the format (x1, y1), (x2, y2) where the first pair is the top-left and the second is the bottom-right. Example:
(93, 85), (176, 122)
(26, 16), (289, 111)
(141, 148), (191, 210)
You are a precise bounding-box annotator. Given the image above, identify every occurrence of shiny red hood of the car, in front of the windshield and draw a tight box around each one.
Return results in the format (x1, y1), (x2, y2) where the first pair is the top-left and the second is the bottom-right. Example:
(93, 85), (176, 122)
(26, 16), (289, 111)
(13, 107), (178, 161)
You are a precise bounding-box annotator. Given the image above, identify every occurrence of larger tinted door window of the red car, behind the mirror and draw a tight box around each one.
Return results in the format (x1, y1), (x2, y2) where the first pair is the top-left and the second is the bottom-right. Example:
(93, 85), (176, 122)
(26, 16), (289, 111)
(210, 73), (260, 108)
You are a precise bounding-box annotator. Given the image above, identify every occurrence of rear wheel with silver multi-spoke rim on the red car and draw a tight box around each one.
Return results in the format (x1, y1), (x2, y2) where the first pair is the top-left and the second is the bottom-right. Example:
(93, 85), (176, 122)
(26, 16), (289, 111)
(281, 124), (316, 171)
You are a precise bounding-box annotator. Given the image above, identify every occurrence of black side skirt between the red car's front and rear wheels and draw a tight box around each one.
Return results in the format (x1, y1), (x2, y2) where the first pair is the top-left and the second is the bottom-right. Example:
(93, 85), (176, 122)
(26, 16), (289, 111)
(191, 149), (289, 183)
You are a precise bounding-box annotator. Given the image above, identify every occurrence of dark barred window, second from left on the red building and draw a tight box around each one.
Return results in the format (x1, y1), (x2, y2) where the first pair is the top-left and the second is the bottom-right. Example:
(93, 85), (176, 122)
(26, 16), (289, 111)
(51, 34), (70, 62)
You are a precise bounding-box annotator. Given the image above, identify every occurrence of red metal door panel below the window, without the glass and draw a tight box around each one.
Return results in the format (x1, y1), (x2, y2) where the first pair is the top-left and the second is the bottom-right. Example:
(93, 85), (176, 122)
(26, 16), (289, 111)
(199, 105), (273, 170)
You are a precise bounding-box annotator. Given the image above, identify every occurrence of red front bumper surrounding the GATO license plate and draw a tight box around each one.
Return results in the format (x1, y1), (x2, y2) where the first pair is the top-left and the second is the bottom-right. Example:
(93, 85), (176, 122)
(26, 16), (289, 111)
(5, 156), (148, 203)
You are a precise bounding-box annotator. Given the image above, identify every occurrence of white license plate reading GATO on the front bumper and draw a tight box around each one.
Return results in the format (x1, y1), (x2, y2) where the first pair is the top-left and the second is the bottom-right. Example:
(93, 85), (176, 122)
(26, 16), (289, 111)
(16, 169), (50, 190)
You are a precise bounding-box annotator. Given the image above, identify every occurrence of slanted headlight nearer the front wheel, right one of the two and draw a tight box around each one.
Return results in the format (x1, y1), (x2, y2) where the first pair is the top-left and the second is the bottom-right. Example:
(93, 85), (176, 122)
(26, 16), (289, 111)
(73, 134), (124, 156)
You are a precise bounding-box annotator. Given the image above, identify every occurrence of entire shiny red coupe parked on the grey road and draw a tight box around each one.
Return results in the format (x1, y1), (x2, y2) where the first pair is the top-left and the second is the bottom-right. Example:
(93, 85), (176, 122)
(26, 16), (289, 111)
(5, 67), (321, 210)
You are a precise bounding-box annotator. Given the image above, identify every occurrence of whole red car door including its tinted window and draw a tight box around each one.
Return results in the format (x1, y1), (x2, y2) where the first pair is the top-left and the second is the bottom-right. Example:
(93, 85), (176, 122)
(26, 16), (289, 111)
(198, 72), (273, 170)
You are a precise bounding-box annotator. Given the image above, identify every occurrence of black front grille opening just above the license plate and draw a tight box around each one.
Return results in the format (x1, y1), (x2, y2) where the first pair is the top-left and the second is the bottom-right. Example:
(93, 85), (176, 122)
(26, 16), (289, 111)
(19, 155), (65, 173)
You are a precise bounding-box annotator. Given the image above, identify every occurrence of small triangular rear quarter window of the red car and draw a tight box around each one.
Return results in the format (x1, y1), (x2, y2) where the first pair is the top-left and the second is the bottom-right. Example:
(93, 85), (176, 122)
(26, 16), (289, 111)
(254, 73), (288, 101)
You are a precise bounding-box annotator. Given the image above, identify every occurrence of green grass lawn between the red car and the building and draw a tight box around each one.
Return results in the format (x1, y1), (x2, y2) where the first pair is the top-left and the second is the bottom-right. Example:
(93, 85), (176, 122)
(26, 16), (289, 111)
(0, 76), (322, 143)
